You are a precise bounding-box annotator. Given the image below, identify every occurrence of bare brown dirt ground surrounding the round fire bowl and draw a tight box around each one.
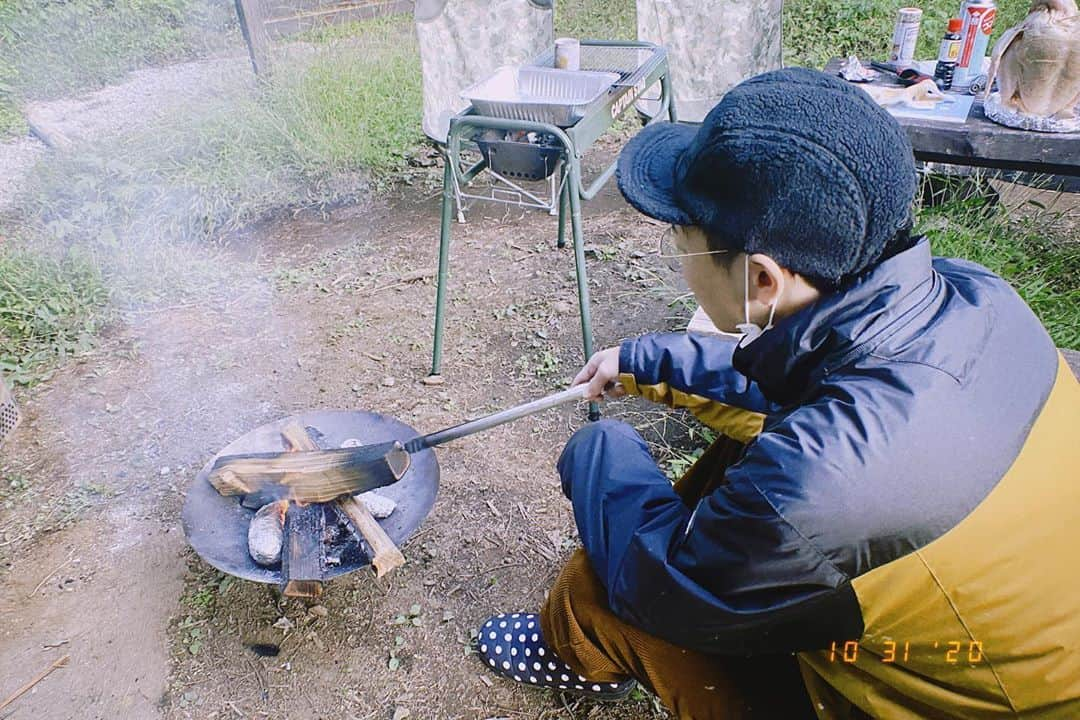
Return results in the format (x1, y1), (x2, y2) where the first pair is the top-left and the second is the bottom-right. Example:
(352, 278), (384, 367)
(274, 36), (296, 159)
(0, 153), (688, 720)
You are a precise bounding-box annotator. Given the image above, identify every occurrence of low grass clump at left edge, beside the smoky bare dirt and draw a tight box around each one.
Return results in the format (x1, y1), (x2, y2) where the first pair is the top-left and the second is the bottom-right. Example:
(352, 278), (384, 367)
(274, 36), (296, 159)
(0, 239), (109, 384)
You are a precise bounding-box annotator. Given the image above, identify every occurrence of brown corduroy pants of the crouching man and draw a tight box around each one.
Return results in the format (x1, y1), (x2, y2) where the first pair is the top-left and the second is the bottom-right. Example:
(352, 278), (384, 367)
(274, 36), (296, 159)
(540, 438), (814, 720)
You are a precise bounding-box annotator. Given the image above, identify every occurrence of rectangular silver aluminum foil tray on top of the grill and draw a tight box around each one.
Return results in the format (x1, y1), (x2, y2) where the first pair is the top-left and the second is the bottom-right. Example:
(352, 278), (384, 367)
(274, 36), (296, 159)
(461, 65), (620, 127)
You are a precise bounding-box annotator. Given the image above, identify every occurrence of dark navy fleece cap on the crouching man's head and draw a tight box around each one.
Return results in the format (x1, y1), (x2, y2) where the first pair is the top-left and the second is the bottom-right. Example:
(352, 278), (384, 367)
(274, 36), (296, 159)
(618, 68), (916, 284)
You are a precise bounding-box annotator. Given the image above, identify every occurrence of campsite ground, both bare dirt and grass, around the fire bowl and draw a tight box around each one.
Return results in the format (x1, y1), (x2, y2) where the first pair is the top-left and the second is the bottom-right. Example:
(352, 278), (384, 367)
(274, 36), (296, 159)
(0, 0), (1080, 720)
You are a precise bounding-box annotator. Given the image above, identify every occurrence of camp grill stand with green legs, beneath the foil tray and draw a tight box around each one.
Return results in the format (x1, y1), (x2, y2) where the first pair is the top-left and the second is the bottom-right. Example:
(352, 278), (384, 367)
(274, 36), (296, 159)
(431, 40), (675, 420)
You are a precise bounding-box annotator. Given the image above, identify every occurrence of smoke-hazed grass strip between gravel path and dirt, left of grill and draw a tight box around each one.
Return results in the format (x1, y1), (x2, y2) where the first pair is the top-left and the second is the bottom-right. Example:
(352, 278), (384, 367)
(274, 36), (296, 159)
(22, 13), (421, 246)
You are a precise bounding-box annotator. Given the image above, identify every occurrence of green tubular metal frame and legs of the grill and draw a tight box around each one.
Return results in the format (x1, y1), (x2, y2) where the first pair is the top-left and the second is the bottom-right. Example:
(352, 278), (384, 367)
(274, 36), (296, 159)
(431, 41), (676, 420)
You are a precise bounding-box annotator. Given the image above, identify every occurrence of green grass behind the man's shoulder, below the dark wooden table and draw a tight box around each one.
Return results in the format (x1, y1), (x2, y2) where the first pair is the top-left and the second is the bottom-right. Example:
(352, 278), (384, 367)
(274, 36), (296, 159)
(918, 185), (1080, 350)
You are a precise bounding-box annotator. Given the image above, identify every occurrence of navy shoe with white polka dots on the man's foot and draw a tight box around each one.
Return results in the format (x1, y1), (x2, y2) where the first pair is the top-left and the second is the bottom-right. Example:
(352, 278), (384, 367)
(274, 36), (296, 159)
(476, 612), (634, 699)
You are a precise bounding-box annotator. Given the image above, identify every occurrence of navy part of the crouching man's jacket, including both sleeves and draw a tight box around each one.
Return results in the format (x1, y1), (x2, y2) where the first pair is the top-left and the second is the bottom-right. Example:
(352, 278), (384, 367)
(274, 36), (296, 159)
(559, 239), (1058, 654)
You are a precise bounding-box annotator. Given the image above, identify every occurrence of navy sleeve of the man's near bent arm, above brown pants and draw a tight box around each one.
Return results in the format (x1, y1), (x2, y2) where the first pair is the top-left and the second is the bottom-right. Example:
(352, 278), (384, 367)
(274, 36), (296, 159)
(558, 421), (862, 655)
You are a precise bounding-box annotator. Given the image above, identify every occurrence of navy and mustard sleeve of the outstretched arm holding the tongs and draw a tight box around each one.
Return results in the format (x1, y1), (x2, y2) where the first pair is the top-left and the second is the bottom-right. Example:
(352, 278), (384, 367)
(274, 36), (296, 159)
(619, 332), (772, 443)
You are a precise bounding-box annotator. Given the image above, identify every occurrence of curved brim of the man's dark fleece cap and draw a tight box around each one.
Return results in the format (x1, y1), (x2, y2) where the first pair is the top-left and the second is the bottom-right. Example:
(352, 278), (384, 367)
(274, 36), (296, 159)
(617, 122), (698, 225)
